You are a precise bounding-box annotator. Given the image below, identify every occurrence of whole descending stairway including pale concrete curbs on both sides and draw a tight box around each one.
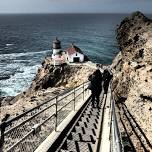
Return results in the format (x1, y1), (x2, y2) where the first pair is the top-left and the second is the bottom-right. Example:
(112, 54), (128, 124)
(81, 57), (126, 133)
(35, 83), (124, 152)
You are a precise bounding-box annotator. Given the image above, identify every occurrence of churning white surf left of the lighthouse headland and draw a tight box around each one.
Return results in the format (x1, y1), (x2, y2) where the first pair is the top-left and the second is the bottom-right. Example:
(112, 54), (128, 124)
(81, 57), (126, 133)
(0, 50), (50, 96)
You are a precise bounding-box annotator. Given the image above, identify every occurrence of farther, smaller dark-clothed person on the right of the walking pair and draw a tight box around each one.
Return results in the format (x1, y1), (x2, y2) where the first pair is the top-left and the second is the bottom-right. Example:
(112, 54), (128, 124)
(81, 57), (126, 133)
(103, 69), (113, 94)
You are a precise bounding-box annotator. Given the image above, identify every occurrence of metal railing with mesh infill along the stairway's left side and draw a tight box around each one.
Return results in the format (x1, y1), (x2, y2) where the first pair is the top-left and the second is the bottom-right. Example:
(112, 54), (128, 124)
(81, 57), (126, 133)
(0, 82), (90, 152)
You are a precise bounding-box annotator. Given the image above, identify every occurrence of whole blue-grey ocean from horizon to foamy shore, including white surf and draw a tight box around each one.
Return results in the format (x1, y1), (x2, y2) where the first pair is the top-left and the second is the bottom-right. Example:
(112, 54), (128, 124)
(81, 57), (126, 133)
(0, 14), (151, 96)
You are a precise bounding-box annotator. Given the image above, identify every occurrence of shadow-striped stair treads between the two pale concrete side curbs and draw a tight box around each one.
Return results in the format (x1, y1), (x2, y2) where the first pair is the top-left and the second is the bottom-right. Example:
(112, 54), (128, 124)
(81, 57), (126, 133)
(53, 91), (104, 152)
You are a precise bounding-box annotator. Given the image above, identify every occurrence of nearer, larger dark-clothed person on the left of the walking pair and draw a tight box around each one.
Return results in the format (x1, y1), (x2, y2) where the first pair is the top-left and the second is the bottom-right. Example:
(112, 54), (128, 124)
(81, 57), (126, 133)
(89, 70), (102, 107)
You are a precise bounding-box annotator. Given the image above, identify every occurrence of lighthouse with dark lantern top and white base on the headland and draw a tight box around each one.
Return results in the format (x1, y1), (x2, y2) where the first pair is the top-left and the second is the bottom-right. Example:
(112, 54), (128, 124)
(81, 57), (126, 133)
(52, 38), (65, 66)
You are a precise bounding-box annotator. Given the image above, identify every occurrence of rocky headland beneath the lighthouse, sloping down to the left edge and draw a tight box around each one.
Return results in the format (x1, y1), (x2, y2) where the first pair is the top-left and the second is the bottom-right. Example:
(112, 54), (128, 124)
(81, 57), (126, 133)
(0, 57), (96, 120)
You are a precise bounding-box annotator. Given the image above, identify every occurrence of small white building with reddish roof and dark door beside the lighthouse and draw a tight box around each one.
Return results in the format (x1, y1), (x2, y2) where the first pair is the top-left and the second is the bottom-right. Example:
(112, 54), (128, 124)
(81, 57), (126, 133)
(65, 44), (86, 63)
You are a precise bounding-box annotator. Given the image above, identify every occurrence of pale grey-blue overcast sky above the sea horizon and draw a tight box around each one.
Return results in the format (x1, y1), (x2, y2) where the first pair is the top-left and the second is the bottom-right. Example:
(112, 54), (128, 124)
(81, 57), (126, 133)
(0, 0), (152, 13)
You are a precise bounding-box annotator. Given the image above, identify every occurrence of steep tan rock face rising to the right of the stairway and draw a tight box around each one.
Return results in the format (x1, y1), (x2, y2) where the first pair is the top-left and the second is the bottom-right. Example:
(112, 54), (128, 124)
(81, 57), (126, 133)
(112, 12), (152, 142)
